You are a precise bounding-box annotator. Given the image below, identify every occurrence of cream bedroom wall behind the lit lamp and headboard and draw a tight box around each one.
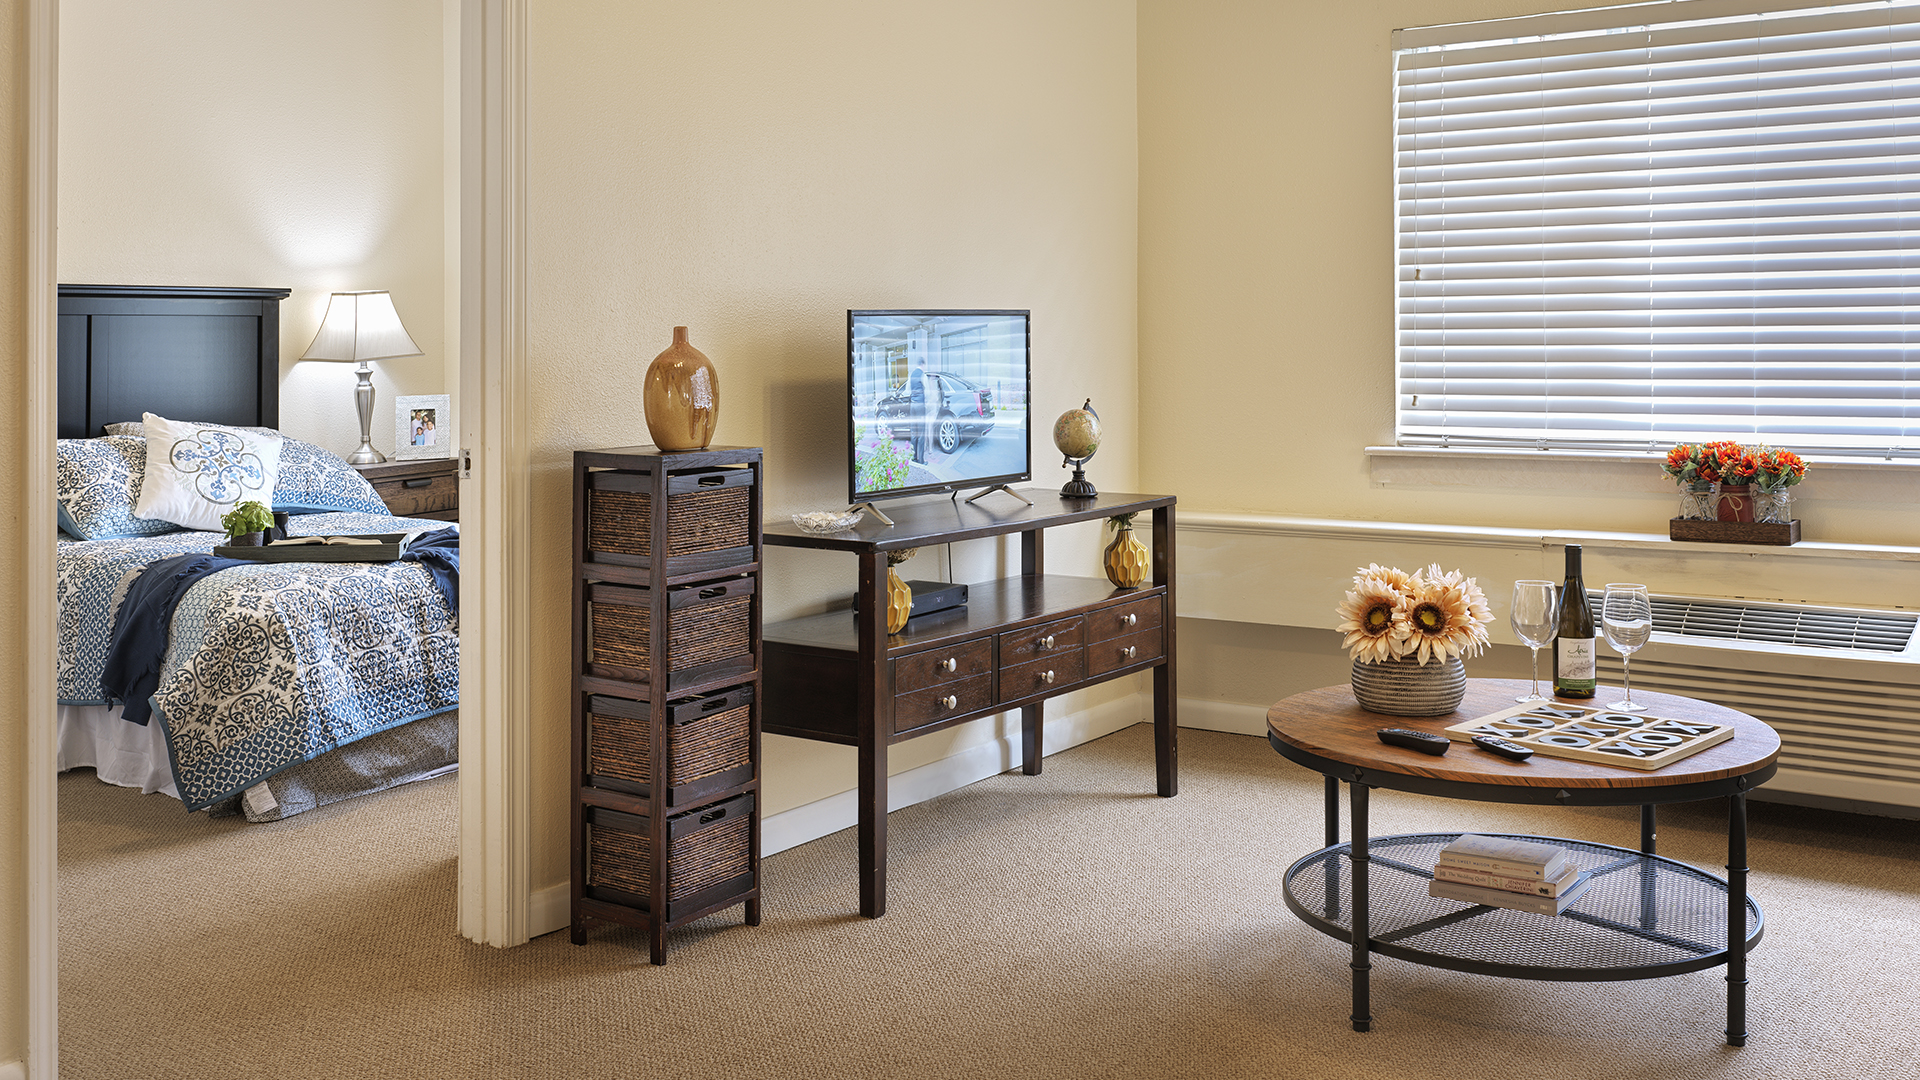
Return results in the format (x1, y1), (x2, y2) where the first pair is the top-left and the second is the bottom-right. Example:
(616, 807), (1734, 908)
(60, 0), (459, 454)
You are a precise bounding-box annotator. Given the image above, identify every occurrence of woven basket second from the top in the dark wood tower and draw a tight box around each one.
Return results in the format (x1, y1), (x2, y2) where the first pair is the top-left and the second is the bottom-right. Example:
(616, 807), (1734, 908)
(588, 582), (753, 671)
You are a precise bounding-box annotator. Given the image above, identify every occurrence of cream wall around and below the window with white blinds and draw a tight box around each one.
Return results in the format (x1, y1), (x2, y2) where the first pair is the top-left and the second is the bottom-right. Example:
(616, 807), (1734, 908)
(1140, 0), (1920, 544)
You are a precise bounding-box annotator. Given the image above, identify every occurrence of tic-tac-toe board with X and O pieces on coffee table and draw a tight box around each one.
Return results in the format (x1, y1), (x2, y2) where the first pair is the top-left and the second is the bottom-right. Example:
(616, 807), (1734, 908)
(1446, 701), (1734, 773)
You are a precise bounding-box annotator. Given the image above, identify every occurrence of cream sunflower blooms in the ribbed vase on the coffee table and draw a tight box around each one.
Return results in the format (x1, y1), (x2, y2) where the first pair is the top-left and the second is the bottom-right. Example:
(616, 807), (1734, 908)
(1336, 563), (1494, 667)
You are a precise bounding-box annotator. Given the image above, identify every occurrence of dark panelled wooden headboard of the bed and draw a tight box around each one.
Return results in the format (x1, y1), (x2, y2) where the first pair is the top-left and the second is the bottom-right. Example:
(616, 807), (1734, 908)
(60, 284), (292, 438)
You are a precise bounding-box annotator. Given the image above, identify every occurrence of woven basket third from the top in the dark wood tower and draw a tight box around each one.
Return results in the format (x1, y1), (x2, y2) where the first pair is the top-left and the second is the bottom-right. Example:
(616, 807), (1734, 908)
(588, 686), (753, 801)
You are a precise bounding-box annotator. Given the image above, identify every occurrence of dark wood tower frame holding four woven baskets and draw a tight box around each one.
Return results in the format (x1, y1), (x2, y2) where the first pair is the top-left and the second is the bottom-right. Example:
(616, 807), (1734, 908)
(572, 446), (764, 965)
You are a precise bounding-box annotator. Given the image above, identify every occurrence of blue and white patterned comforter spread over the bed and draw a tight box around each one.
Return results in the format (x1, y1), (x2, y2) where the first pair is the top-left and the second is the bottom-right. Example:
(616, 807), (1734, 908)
(56, 513), (459, 809)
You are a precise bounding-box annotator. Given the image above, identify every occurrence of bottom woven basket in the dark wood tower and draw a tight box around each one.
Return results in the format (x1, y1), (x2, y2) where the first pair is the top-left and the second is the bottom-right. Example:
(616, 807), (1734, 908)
(588, 796), (753, 917)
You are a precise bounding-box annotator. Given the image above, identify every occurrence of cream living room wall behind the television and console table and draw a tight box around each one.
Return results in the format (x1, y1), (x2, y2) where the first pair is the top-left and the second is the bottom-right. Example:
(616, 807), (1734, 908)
(528, 0), (1139, 886)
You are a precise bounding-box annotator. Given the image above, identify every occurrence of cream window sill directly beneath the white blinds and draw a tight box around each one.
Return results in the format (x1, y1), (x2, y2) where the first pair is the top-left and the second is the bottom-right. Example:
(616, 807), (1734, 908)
(1367, 446), (1920, 502)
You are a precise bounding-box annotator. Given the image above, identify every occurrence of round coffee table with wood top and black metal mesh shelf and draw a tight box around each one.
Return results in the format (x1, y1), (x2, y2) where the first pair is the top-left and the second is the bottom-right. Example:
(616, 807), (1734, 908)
(1267, 678), (1780, 1045)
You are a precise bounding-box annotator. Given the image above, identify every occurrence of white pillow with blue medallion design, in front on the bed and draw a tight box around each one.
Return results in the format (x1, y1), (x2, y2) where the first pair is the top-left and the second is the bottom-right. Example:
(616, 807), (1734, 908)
(132, 413), (280, 532)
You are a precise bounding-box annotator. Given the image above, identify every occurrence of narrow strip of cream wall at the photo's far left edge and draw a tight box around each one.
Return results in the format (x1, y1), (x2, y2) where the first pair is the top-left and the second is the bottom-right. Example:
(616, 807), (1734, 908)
(0, 0), (29, 1070)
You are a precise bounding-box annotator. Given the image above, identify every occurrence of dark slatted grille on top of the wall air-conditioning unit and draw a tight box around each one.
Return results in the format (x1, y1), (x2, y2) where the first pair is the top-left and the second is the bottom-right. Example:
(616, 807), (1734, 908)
(1588, 590), (1920, 653)
